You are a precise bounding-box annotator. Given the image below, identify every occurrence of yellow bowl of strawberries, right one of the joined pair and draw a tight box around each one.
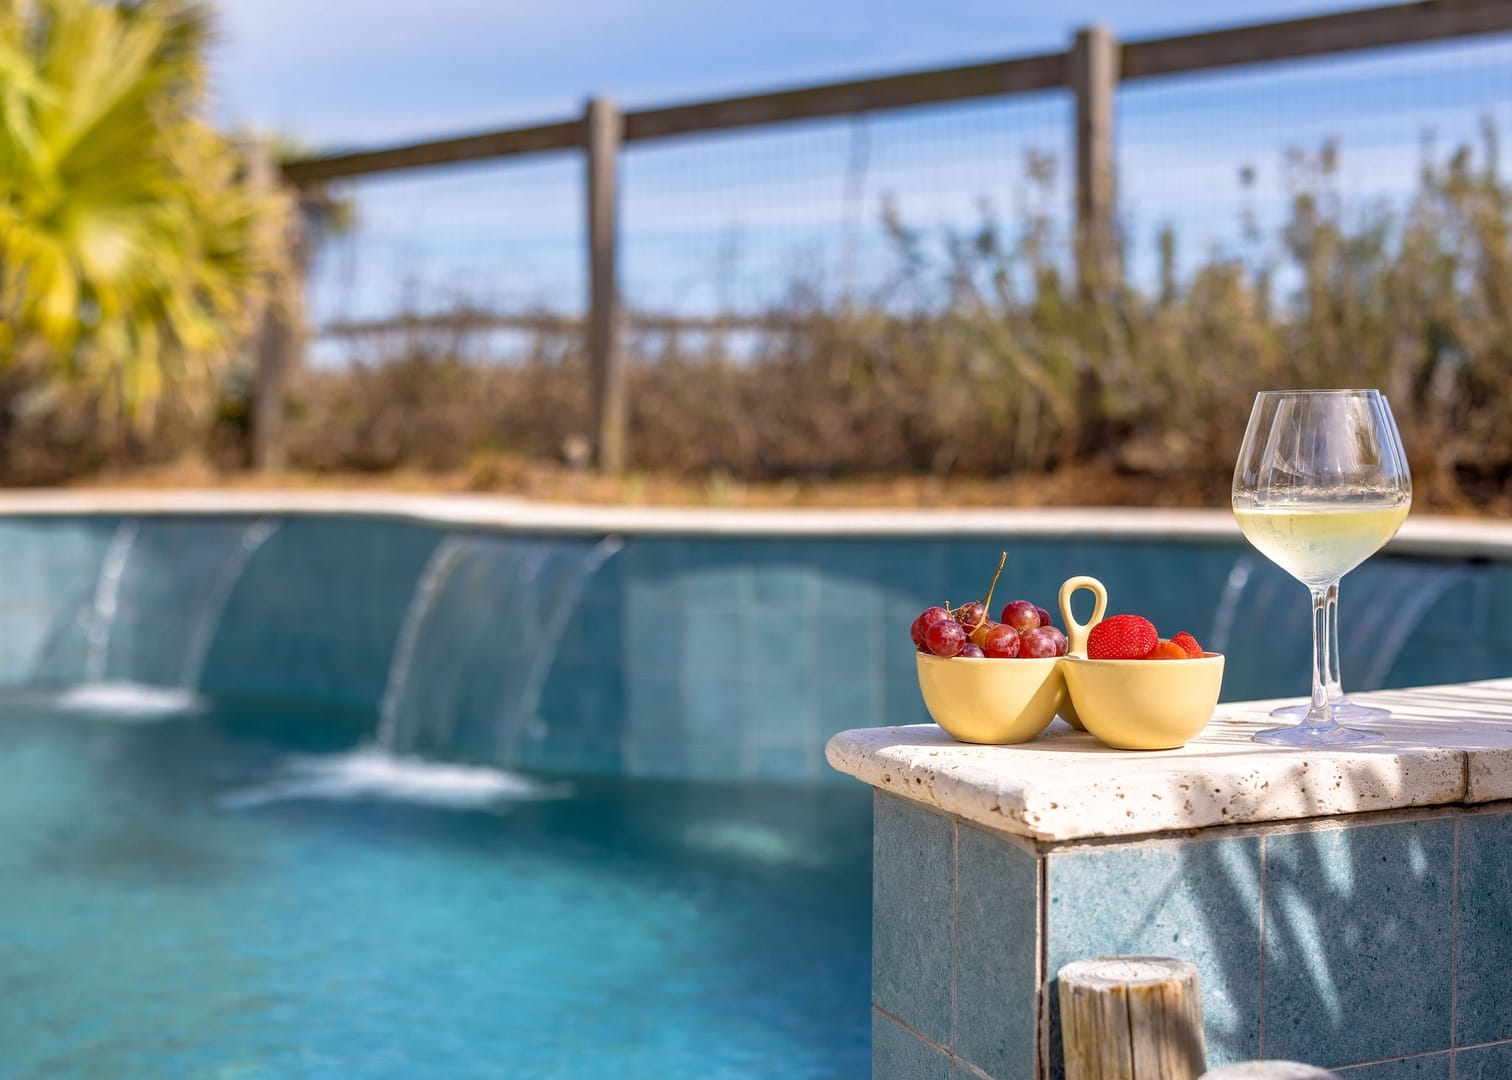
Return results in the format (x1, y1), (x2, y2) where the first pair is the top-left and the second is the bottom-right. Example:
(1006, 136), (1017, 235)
(1063, 614), (1223, 750)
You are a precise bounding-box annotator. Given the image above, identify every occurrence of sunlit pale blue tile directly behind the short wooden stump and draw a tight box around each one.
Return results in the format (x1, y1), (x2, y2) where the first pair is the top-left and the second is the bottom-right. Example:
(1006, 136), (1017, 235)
(1046, 836), (1264, 1075)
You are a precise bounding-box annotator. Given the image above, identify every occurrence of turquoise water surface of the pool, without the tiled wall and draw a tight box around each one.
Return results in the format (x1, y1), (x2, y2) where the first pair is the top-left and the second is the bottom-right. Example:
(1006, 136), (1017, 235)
(0, 699), (871, 1080)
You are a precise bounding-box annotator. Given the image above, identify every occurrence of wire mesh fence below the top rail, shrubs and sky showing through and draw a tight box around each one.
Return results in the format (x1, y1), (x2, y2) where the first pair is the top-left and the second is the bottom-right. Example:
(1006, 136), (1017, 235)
(285, 6), (1512, 505)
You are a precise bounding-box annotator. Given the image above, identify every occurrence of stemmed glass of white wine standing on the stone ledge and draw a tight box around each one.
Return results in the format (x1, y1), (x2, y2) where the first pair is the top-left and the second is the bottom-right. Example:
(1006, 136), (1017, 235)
(1234, 390), (1412, 746)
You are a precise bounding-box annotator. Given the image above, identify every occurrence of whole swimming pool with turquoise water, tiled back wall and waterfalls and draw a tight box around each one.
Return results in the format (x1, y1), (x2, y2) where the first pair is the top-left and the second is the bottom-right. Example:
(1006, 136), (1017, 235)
(0, 499), (1512, 1078)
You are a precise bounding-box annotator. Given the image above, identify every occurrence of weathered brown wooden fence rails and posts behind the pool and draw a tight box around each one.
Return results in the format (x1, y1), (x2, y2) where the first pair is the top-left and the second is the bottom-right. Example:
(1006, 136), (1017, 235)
(271, 0), (1512, 472)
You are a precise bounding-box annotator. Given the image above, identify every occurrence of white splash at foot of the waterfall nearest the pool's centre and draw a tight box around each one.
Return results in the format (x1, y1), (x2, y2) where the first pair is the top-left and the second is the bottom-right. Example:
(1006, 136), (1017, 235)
(216, 747), (573, 809)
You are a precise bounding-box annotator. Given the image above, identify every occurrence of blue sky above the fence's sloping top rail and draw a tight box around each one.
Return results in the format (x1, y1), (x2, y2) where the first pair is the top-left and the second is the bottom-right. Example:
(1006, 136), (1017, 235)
(216, 0), (1328, 147)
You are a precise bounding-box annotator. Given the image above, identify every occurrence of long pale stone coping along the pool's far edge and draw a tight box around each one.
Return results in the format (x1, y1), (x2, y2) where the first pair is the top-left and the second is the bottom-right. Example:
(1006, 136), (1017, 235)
(0, 489), (1512, 560)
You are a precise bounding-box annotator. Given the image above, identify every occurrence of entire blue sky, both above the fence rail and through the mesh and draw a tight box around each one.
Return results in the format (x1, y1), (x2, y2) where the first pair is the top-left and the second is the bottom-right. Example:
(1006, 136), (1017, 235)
(215, 0), (1512, 349)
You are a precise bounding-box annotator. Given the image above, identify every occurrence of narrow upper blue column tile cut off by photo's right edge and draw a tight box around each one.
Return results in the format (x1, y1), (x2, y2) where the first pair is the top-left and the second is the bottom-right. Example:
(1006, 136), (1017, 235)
(1455, 812), (1512, 1040)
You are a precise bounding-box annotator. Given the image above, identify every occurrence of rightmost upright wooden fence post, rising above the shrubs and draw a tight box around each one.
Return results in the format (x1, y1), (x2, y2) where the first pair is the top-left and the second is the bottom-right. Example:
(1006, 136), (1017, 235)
(1069, 26), (1119, 289)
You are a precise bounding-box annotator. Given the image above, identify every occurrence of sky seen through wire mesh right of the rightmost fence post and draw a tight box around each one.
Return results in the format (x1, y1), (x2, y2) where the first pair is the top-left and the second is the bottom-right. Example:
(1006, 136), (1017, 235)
(1117, 36), (1512, 289)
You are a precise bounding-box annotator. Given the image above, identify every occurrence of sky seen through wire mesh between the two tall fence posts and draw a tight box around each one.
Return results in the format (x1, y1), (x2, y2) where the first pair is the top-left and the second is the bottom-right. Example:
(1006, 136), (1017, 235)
(621, 94), (1070, 318)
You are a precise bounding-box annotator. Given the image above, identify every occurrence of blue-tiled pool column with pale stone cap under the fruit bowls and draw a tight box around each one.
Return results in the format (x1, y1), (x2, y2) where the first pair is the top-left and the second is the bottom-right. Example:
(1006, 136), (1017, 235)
(830, 682), (1512, 1080)
